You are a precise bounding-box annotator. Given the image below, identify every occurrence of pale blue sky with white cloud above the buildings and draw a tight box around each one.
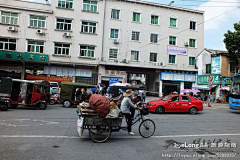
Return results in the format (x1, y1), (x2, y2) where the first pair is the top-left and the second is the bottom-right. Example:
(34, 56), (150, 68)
(29, 0), (240, 50)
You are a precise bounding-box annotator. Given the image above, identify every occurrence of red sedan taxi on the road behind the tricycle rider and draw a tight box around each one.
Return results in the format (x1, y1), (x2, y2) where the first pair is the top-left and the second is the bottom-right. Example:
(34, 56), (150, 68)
(147, 95), (203, 114)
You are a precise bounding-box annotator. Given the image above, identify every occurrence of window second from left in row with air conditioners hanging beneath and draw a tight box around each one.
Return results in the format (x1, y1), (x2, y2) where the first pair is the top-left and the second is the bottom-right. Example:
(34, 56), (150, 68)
(29, 15), (46, 28)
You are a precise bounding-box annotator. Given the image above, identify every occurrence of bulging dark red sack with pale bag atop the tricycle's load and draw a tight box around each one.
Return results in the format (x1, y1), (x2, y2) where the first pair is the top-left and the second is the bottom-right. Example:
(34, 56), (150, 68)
(89, 94), (120, 118)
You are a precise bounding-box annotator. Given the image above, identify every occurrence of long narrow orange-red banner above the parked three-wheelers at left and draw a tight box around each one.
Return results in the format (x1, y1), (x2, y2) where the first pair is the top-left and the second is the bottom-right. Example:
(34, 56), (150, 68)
(26, 74), (71, 82)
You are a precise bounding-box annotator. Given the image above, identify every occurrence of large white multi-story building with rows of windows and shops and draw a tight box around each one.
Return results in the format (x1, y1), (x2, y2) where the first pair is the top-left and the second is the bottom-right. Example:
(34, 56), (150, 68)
(0, 0), (204, 93)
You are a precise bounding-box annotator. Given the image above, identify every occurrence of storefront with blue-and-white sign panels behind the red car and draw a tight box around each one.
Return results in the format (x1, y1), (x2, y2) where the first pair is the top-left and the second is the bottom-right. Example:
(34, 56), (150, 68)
(159, 71), (196, 96)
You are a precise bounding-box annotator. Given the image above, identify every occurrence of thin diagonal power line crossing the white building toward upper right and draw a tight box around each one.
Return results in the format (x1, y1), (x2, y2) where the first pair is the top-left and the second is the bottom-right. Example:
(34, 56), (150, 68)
(115, 7), (239, 55)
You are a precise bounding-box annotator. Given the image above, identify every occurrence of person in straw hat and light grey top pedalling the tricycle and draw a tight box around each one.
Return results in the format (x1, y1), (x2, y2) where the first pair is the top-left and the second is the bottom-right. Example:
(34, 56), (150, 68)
(121, 89), (141, 135)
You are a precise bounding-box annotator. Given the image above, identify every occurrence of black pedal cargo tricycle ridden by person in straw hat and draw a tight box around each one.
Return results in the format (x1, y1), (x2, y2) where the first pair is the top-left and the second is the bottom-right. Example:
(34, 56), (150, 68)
(79, 103), (155, 143)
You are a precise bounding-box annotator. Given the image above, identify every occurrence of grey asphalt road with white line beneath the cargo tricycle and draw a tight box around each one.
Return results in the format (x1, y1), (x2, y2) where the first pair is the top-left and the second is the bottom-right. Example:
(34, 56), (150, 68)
(0, 98), (240, 160)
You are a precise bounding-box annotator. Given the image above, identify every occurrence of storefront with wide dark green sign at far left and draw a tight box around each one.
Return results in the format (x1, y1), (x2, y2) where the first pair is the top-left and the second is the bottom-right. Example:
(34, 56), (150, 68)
(0, 51), (49, 79)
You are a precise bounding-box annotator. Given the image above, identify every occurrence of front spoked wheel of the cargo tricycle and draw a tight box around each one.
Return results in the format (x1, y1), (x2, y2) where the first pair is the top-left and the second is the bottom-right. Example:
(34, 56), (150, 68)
(139, 119), (155, 138)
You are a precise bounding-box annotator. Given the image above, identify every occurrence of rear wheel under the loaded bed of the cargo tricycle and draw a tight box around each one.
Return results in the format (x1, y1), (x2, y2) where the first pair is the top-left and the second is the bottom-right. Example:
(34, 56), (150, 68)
(89, 121), (111, 143)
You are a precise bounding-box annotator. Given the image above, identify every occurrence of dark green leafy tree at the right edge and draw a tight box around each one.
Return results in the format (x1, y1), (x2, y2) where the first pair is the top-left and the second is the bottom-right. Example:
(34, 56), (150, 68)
(223, 22), (240, 65)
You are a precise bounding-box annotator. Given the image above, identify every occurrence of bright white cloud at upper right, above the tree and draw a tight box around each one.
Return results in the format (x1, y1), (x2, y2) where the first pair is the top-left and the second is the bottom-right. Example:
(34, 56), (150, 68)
(197, 0), (240, 30)
